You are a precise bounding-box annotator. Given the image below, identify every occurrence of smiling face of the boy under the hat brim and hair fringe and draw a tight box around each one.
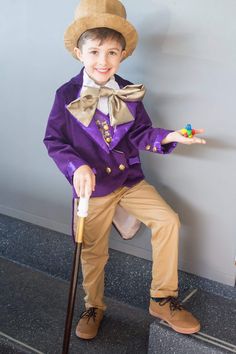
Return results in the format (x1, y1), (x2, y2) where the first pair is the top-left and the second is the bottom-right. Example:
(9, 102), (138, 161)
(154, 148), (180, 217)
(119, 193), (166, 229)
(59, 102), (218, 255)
(74, 39), (126, 85)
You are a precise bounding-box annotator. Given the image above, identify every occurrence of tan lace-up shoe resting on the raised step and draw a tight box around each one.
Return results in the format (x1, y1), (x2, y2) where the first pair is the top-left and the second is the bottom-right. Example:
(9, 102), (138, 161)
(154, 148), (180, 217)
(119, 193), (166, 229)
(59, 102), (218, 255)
(149, 296), (200, 334)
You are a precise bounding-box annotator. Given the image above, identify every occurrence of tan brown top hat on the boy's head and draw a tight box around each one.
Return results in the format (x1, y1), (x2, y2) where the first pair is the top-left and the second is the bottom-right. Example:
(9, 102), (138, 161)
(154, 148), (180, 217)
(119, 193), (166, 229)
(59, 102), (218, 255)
(64, 0), (138, 59)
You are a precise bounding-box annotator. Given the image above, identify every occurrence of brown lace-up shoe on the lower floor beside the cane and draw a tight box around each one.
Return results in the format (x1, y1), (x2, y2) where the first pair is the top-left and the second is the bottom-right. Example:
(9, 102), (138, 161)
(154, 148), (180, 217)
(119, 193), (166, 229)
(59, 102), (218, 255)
(75, 307), (104, 339)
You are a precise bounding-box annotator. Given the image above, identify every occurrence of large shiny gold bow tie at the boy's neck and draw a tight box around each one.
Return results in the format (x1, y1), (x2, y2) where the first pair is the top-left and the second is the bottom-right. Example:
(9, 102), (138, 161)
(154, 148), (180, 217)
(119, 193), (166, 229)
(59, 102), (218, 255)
(66, 85), (145, 127)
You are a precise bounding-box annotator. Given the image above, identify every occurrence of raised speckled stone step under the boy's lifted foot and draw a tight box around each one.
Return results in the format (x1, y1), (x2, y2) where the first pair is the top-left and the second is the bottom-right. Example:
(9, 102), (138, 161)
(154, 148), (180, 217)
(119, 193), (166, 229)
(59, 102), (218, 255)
(148, 290), (236, 354)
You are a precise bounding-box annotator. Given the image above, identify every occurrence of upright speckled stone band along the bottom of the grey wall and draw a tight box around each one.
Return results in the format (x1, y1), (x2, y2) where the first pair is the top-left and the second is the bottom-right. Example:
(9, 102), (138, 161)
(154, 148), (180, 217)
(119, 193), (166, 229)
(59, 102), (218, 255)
(0, 214), (236, 310)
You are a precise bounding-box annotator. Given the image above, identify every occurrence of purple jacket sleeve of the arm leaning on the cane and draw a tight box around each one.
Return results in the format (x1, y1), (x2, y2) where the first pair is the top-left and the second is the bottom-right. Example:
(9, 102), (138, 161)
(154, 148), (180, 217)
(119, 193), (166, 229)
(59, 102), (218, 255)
(43, 91), (88, 184)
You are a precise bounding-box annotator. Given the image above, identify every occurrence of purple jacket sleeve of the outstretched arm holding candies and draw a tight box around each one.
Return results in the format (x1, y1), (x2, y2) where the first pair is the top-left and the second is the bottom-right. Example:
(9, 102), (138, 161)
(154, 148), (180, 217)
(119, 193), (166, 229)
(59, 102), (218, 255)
(129, 102), (177, 154)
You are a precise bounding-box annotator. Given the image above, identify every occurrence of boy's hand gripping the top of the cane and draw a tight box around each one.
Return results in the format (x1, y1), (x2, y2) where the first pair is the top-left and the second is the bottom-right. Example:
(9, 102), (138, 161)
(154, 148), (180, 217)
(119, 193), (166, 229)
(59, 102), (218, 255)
(73, 165), (96, 197)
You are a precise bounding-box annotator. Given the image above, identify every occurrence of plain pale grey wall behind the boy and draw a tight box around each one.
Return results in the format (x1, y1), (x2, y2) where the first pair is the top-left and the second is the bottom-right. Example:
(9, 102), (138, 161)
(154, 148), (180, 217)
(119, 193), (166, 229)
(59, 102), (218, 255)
(0, 0), (236, 285)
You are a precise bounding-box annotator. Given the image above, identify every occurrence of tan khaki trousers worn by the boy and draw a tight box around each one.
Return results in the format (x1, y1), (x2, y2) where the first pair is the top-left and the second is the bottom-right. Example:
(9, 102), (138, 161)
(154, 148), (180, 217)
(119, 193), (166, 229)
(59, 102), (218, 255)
(74, 180), (179, 310)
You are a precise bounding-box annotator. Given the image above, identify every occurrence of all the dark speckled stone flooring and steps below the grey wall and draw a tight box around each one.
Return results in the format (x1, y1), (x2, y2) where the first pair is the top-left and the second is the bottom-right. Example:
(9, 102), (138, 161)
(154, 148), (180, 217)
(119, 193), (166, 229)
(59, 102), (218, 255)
(0, 215), (236, 354)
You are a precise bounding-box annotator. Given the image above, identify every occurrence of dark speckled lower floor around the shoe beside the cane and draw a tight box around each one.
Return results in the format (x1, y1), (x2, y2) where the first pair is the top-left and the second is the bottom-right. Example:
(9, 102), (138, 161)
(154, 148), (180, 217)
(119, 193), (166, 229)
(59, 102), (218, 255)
(0, 258), (153, 354)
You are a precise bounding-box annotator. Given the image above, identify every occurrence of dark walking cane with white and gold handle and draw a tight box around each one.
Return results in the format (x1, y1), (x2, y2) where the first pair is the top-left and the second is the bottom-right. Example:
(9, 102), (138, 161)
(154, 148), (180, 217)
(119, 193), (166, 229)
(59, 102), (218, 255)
(62, 197), (89, 354)
